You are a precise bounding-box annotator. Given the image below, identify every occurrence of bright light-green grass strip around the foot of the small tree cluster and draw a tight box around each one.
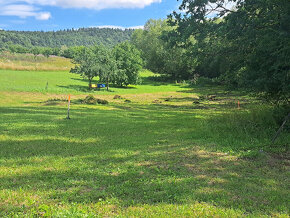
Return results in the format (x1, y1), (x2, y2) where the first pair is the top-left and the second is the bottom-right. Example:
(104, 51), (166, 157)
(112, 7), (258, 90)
(0, 70), (190, 94)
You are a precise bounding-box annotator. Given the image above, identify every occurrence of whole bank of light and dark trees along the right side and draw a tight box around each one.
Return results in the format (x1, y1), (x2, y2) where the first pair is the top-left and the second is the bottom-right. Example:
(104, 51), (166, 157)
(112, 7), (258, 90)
(132, 0), (290, 102)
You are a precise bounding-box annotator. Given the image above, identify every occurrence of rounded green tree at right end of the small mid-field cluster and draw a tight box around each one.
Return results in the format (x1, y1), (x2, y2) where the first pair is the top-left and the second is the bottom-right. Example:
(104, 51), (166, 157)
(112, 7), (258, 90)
(113, 42), (143, 86)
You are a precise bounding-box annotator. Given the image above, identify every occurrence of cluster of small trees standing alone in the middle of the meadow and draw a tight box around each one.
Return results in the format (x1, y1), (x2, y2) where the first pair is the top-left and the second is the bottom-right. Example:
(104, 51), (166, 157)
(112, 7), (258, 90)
(70, 42), (143, 89)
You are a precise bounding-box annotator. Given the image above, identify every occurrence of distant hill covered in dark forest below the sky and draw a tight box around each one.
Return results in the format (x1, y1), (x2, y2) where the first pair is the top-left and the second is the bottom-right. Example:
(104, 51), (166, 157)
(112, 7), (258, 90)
(0, 28), (134, 48)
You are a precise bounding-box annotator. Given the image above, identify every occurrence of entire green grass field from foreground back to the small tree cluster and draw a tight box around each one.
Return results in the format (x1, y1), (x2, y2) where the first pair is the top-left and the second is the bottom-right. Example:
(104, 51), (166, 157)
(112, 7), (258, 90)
(0, 66), (290, 217)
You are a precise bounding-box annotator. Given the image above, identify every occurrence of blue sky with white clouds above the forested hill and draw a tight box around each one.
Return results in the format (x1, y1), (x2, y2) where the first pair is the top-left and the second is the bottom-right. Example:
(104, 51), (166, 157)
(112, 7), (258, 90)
(0, 0), (180, 31)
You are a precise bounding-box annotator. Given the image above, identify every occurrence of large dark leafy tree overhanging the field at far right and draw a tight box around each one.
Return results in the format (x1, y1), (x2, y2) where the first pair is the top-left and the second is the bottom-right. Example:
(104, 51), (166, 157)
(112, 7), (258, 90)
(169, 0), (290, 100)
